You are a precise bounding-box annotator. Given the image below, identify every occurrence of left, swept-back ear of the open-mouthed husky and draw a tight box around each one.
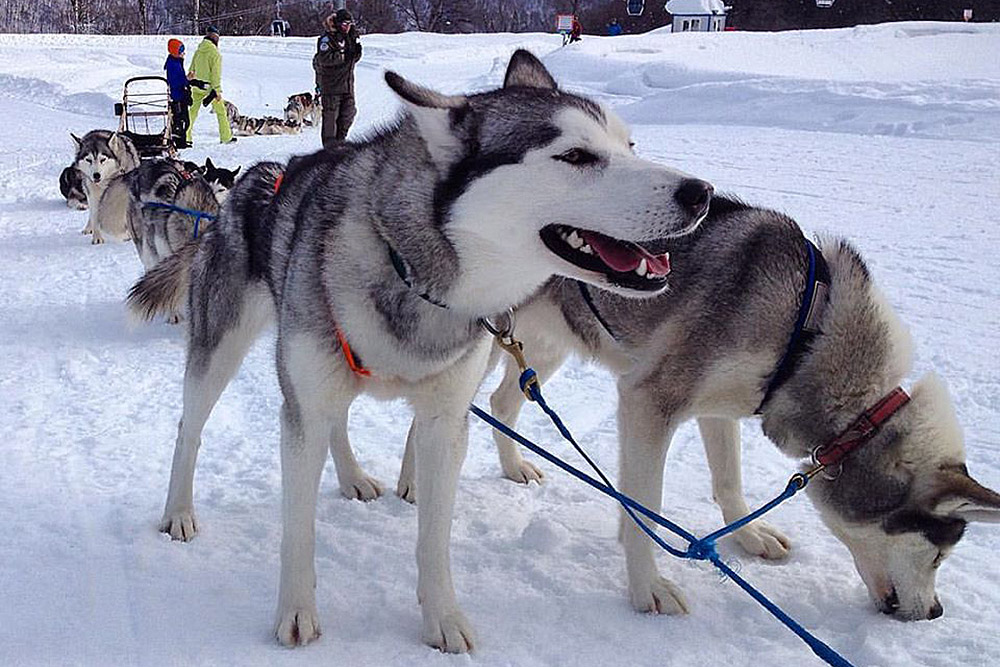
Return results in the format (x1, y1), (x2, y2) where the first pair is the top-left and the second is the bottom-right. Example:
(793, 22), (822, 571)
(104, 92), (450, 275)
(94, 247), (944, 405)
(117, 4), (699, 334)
(385, 72), (469, 169)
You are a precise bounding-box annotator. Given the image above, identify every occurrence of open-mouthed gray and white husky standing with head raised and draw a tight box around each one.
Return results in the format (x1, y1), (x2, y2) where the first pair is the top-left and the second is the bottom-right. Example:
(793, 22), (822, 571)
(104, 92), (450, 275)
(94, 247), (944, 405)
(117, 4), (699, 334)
(129, 51), (711, 652)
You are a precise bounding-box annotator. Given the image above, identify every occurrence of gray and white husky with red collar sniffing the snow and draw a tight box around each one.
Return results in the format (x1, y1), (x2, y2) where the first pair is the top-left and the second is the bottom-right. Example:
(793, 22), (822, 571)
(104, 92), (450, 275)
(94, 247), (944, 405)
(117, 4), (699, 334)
(478, 197), (1000, 620)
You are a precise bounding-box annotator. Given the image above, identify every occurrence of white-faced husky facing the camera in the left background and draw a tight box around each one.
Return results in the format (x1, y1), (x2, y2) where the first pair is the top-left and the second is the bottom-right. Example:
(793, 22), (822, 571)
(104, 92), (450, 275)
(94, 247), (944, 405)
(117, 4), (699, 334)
(70, 130), (139, 243)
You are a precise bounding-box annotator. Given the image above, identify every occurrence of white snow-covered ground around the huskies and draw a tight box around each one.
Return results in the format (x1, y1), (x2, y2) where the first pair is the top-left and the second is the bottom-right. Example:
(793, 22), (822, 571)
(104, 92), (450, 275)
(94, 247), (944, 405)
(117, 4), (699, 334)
(0, 23), (1000, 667)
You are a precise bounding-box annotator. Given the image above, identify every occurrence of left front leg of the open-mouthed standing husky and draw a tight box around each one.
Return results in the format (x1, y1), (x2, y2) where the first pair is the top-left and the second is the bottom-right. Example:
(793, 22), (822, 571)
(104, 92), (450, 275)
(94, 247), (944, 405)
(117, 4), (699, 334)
(274, 332), (355, 646)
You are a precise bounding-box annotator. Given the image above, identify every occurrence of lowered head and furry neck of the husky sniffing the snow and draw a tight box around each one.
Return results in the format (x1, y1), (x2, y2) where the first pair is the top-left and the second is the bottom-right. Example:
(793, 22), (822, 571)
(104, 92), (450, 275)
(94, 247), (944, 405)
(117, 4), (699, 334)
(764, 244), (1000, 620)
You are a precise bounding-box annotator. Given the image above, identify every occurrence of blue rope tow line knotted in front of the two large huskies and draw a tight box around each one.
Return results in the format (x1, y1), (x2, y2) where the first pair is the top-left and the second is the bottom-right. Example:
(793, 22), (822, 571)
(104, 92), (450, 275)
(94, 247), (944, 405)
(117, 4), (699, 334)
(469, 368), (854, 667)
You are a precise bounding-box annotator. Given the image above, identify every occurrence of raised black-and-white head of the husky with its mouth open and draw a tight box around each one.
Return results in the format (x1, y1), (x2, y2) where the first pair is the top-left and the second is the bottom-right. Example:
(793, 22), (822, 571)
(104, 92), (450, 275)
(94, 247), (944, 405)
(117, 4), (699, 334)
(386, 51), (712, 312)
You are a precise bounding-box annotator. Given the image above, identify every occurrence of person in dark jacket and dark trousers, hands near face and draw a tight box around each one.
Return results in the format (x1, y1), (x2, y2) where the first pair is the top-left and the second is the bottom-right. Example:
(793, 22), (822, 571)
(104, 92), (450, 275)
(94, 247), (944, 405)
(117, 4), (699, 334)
(313, 9), (361, 148)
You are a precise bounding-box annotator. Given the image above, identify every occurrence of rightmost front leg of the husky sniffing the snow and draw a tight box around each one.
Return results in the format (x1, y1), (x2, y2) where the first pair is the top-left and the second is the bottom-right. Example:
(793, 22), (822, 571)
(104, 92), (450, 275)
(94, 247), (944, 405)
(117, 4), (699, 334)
(698, 417), (790, 560)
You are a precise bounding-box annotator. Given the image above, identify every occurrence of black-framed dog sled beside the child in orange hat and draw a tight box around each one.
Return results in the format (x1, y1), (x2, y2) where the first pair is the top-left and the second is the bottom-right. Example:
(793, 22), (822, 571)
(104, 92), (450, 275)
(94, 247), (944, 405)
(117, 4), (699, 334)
(115, 76), (175, 158)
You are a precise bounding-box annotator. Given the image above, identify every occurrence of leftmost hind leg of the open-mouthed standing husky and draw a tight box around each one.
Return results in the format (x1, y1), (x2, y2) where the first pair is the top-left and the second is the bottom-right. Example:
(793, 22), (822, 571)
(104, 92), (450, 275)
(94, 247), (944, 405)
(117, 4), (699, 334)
(160, 285), (273, 541)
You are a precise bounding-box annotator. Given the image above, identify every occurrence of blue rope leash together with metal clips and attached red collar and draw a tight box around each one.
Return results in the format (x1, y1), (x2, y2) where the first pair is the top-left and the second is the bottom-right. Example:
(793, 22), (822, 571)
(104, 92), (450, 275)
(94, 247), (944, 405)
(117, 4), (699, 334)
(469, 319), (868, 667)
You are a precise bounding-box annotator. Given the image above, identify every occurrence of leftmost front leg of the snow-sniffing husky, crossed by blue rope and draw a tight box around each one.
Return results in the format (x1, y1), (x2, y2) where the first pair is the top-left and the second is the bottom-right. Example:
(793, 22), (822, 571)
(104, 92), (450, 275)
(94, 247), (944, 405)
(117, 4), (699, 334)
(618, 384), (688, 614)
